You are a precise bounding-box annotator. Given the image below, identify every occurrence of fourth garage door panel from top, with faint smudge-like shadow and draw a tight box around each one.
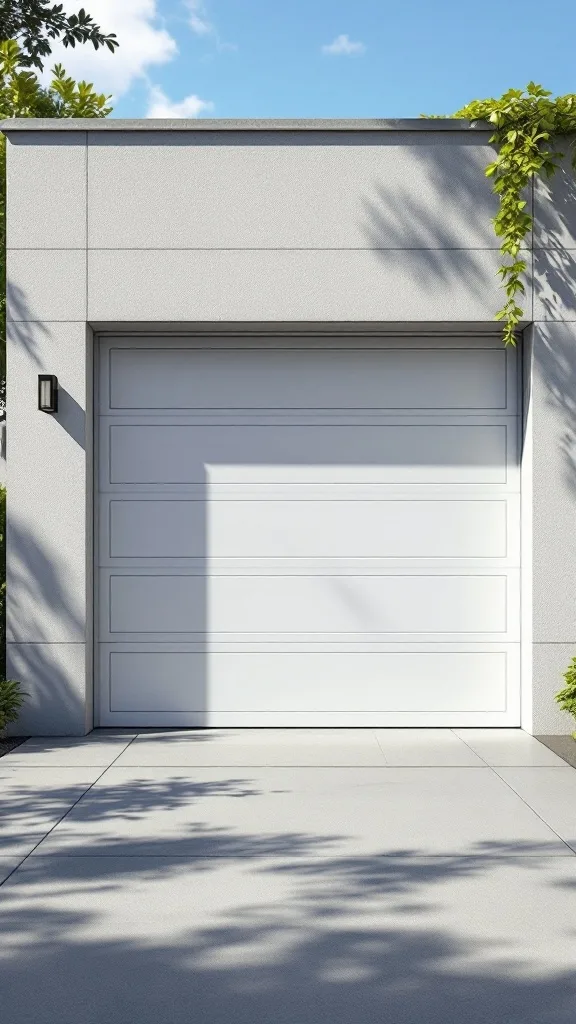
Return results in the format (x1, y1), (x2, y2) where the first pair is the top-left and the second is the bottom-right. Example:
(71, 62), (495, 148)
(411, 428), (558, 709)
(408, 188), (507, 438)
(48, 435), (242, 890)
(102, 571), (510, 641)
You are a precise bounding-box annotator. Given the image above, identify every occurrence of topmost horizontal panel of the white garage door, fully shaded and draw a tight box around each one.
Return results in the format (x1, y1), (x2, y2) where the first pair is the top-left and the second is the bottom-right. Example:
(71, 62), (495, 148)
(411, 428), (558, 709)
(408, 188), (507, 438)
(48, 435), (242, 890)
(109, 344), (506, 412)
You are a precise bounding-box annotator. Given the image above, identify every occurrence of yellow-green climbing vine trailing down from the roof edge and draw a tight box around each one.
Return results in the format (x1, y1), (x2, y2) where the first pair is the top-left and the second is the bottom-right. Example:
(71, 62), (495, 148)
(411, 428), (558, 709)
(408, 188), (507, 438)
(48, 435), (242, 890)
(428, 82), (576, 345)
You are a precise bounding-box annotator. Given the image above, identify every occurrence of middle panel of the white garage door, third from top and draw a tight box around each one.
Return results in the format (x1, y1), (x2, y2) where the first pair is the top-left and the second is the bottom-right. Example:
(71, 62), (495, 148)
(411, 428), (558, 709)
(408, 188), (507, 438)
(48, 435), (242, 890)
(102, 499), (508, 559)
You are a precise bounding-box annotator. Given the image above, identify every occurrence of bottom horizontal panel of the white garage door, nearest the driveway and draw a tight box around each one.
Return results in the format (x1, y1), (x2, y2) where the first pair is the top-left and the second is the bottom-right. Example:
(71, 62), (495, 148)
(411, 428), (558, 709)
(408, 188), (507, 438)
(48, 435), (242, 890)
(105, 646), (515, 712)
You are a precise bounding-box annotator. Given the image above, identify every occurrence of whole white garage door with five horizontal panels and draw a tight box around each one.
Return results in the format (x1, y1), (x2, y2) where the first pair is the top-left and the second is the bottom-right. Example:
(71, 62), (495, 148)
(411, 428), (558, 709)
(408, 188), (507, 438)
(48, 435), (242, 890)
(97, 337), (520, 726)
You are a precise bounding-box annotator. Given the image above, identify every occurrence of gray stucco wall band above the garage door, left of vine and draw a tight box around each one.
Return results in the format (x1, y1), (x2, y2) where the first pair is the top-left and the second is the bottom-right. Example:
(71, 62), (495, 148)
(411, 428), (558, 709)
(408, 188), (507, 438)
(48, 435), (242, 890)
(8, 131), (510, 323)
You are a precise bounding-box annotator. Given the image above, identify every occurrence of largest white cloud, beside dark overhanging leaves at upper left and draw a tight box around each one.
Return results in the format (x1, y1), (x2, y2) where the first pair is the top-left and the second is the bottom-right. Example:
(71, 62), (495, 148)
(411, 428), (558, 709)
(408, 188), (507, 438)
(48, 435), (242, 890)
(42, 0), (177, 97)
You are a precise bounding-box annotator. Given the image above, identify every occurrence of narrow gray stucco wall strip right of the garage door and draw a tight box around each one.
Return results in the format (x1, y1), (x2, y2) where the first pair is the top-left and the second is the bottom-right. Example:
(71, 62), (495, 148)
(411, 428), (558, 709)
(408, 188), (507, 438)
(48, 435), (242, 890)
(526, 155), (576, 733)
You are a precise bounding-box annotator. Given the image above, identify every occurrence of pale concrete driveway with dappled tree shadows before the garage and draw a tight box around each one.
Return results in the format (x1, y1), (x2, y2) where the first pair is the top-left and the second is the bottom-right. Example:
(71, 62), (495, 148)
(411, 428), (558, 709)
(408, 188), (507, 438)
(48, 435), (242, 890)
(0, 729), (576, 1024)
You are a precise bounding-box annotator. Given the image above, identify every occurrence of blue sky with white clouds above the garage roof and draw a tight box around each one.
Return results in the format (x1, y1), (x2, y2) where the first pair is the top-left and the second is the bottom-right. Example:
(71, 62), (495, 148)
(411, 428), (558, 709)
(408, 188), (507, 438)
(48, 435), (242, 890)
(47, 0), (576, 118)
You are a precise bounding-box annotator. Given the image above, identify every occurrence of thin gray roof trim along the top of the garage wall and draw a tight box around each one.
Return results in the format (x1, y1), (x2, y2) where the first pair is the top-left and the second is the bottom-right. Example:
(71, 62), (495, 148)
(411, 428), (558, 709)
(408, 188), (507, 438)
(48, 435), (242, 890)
(0, 118), (491, 133)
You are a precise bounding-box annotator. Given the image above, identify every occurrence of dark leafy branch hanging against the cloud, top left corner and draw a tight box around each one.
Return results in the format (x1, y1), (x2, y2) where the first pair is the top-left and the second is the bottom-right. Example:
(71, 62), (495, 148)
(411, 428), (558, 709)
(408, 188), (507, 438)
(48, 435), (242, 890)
(0, 0), (118, 70)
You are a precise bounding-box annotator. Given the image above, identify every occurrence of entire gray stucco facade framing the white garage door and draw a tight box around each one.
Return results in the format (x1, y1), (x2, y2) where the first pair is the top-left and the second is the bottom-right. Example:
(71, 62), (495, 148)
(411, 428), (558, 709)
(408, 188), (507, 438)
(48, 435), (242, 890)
(2, 122), (576, 733)
